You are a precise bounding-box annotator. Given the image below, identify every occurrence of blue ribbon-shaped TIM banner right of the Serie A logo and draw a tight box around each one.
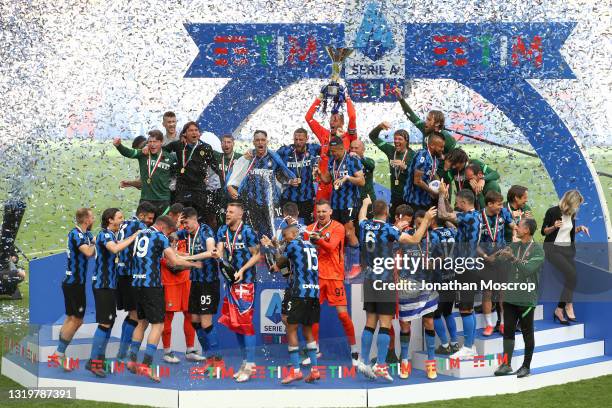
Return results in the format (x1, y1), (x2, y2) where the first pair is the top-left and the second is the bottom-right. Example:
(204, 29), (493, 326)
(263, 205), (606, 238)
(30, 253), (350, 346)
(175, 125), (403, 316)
(404, 23), (575, 80)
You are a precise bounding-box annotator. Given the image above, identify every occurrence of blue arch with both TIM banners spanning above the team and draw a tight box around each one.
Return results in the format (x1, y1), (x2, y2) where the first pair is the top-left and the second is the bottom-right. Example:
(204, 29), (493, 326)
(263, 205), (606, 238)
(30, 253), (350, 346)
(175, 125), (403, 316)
(185, 22), (610, 267)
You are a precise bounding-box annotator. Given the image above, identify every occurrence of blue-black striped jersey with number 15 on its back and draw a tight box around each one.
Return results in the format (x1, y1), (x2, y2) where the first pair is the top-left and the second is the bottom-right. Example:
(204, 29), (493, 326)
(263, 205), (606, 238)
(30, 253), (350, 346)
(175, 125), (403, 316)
(283, 238), (319, 299)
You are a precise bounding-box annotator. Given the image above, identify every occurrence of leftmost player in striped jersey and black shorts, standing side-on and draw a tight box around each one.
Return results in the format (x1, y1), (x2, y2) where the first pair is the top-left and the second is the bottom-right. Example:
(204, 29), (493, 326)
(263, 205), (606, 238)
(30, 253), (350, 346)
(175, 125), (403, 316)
(54, 208), (95, 371)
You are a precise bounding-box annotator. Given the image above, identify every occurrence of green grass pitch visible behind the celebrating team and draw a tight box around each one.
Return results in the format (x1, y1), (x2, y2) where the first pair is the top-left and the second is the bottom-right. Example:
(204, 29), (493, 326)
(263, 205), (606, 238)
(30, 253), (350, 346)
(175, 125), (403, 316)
(10, 141), (612, 256)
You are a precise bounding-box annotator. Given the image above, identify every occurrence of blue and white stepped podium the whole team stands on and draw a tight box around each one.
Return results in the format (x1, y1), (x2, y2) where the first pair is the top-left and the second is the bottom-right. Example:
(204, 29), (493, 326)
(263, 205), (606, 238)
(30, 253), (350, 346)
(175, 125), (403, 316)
(2, 250), (612, 407)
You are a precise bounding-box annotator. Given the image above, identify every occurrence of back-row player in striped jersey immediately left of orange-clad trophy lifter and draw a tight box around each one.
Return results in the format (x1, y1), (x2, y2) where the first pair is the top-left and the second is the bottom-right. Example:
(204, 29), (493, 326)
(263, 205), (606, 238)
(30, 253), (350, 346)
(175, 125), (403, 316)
(276, 128), (321, 224)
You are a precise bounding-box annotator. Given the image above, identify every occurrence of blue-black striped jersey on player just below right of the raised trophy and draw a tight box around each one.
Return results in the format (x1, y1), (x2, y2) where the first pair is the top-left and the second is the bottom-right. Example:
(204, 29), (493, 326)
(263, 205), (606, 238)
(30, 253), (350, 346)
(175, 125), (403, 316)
(327, 153), (363, 210)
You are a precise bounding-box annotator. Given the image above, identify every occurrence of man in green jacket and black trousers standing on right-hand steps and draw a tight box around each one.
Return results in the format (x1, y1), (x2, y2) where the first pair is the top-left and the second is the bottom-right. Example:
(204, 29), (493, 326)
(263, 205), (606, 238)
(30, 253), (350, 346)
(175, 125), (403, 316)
(495, 218), (544, 378)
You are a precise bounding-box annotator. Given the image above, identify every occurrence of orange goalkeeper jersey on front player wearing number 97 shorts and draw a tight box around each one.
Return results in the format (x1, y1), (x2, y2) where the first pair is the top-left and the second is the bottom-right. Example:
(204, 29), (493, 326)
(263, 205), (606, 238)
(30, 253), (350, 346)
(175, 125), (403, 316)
(305, 220), (344, 281)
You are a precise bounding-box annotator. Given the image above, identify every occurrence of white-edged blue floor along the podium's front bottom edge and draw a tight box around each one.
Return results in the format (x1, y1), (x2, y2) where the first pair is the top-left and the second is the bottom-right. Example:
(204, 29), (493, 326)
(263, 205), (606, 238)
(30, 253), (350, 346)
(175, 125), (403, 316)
(2, 355), (612, 407)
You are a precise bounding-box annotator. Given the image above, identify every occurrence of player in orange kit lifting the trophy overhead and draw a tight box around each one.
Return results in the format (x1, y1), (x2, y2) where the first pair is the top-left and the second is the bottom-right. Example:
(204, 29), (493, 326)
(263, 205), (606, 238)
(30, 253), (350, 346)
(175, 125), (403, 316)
(305, 85), (357, 201)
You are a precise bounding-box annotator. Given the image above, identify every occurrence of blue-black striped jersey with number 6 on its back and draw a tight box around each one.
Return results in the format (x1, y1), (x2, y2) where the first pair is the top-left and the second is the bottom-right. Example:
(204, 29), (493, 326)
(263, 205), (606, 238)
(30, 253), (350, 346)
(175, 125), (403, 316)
(359, 220), (401, 282)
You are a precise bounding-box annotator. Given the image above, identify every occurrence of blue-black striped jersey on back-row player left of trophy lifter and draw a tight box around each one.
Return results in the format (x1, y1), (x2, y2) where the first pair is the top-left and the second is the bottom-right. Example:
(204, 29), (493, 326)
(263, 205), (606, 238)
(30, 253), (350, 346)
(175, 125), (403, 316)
(276, 143), (321, 203)
